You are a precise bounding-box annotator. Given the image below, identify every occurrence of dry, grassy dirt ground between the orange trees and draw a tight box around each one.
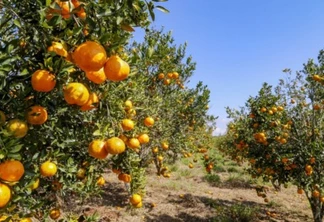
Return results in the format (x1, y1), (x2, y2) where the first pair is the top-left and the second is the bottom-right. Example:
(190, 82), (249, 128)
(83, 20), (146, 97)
(67, 161), (312, 222)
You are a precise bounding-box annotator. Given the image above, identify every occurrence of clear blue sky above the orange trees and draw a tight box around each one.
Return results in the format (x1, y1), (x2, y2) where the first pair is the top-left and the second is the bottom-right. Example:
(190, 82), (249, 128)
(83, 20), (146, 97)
(135, 0), (324, 133)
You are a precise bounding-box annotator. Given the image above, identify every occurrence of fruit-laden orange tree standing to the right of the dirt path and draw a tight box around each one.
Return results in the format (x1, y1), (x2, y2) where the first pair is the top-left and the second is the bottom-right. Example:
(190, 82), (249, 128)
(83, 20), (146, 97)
(223, 51), (324, 221)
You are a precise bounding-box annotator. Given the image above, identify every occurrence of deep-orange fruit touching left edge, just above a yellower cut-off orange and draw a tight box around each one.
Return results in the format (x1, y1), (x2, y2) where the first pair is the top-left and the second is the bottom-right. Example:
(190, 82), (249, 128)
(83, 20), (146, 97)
(0, 160), (25, 182)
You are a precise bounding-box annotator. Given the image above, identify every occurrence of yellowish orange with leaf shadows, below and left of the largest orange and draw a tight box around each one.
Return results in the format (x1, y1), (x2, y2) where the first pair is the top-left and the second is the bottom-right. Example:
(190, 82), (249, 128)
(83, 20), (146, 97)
(64, 82), (90, 106)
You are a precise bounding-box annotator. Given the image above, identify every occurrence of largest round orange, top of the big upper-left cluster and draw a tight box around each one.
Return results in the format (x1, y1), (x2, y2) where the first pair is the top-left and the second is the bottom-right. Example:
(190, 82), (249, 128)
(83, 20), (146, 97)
(72, 41), (107, 72)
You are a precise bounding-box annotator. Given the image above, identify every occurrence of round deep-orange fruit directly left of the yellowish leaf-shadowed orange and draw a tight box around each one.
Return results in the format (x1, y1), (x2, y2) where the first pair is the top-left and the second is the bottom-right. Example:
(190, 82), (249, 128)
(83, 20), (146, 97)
(31, 69), (56, 92)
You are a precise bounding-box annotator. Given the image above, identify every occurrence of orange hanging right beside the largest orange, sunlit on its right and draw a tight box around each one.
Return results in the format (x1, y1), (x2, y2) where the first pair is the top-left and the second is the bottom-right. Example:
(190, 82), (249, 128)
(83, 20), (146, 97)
(104, 55), (130, 82)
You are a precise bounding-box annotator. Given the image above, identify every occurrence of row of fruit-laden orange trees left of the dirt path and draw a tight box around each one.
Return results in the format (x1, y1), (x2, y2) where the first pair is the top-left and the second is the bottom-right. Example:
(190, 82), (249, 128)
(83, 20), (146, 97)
(0, 0), (218, 221)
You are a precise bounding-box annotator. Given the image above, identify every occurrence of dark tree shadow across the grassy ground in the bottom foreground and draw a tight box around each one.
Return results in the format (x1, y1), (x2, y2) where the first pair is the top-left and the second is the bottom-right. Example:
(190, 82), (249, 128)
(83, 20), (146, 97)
(145, 194), (312, 222)
